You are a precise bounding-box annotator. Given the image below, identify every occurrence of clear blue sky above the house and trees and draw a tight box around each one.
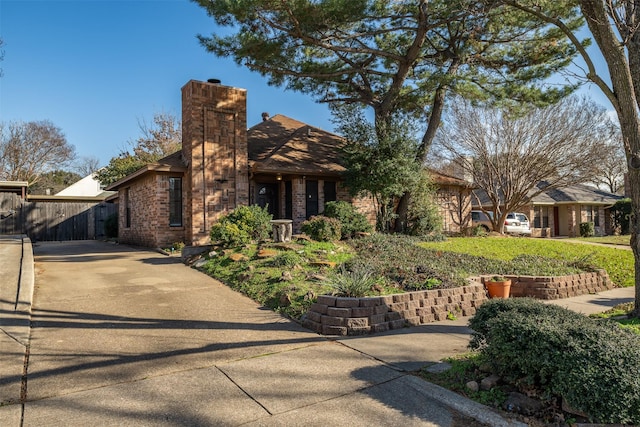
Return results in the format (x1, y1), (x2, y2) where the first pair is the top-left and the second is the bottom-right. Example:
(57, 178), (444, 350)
(0, 0), (610, 171)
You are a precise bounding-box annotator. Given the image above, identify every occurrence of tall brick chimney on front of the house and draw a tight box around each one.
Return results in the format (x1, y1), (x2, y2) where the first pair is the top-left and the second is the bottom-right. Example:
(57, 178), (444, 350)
(182, 79), (249, 245)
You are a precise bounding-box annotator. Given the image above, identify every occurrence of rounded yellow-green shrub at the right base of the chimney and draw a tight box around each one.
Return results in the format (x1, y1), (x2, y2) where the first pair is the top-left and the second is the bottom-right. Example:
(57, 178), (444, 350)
(210, 205), (272, 247)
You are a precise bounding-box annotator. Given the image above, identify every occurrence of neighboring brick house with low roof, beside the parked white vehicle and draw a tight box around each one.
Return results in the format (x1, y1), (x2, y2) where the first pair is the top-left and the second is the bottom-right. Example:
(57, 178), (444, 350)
(472, 184), (622, 237)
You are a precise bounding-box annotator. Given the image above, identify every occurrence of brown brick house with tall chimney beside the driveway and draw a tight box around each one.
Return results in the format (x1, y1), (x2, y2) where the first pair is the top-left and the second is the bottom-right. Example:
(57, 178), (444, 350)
(107, 80), (470, 247)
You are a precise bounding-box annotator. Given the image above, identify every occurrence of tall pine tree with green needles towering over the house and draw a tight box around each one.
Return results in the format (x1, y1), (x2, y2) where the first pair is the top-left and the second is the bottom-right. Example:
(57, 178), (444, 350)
(195, 0), (583, 228)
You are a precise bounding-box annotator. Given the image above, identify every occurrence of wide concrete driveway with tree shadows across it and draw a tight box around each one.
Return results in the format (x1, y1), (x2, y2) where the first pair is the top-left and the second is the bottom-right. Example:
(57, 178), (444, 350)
(0, 241), (514, 427)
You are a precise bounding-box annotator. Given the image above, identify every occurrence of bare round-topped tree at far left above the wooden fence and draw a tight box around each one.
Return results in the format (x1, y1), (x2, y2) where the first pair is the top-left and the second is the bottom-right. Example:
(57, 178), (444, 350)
(0, 120), (75, 186)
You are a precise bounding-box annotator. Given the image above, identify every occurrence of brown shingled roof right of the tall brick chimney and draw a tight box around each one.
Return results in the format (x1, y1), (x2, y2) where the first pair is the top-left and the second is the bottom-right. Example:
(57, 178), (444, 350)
(247, 114), (346, 175)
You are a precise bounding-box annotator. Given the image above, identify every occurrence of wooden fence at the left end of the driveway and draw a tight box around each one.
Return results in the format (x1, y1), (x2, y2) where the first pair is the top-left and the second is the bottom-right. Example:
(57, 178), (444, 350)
(0, 193), (117, 242)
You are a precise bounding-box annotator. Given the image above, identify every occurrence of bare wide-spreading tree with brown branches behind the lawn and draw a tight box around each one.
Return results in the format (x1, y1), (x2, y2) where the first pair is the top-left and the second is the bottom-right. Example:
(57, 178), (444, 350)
(438, 97), (610, 231)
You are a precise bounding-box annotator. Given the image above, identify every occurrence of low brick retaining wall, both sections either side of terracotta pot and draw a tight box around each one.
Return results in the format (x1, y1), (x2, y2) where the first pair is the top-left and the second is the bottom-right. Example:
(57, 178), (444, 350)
(304, 270), (613, 335)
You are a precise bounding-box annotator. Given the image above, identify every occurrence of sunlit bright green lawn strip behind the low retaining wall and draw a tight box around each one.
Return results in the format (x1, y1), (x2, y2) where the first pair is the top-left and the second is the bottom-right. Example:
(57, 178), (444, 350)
(420, 237), (634, 287)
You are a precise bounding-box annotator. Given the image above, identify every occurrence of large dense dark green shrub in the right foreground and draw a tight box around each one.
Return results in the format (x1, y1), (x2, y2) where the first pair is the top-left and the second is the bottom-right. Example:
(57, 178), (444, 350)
(470, 298), (640, 424)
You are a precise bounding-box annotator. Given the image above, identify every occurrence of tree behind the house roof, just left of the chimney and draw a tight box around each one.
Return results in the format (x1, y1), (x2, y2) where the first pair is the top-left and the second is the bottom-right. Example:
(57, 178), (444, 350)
(96, 113), (182, 186)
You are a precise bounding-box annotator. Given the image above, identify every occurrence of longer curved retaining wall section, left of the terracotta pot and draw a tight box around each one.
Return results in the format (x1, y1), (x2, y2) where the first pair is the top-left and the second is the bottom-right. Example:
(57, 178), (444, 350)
(304, 283), (487, 335)
